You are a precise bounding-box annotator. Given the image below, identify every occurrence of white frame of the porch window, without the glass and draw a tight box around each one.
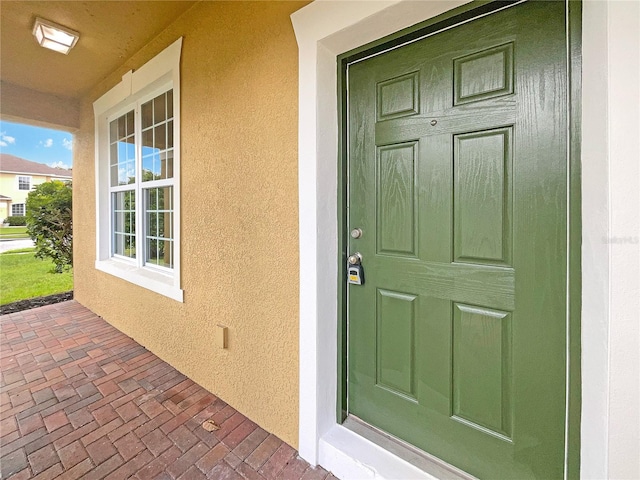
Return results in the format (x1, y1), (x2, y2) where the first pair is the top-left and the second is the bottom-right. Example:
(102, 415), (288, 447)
(93, 38), (184, 302)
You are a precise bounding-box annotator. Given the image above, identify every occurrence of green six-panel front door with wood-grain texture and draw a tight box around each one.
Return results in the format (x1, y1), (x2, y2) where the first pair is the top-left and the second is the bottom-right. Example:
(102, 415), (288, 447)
(347, 2), (568, 479)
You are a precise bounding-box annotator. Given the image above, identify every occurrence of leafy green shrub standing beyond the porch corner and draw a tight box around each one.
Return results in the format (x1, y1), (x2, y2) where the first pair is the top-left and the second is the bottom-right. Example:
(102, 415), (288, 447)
(27, 180), (73, 273)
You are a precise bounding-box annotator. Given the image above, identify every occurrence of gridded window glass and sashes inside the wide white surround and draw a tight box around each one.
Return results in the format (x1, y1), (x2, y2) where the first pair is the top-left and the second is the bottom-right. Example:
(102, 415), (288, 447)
(109, 90), (174, 269)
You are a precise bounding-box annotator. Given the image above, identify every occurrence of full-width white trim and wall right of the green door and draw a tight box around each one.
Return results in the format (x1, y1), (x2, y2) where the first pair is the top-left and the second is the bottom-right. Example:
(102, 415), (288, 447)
(582, 1), (640, 478)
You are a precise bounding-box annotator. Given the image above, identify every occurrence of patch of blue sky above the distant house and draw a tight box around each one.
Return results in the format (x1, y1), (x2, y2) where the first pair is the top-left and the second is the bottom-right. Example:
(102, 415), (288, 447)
(0, 121), (73, 168)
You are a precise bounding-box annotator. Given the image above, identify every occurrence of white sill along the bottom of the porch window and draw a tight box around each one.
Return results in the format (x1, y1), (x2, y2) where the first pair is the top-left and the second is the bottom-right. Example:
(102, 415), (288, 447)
(96, 258), (184, 302)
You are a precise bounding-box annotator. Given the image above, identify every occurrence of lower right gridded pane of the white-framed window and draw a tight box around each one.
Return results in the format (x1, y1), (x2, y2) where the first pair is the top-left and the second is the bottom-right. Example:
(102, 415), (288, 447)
(144, 187), (174, 268)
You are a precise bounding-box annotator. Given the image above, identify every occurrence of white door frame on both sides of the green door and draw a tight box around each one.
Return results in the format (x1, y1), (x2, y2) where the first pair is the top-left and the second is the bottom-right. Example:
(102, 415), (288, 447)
(291, 0), (640, 479)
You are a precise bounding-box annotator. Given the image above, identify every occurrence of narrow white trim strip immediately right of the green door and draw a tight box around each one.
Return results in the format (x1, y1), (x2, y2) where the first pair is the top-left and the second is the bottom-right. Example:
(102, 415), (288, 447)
(580, 1), (609, 479)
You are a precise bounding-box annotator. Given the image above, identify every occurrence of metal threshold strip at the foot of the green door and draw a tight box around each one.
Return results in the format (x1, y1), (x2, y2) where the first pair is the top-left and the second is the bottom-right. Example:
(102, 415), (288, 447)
(342, 415), (477, 480)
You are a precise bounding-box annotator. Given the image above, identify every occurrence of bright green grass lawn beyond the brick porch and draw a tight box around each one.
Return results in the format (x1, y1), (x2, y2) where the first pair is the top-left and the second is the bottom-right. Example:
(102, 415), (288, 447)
(0, 248), (73, 305)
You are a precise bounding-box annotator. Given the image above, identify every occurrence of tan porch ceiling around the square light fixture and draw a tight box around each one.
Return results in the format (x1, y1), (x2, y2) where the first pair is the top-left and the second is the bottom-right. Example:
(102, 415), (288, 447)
(0, 0), (196, 127)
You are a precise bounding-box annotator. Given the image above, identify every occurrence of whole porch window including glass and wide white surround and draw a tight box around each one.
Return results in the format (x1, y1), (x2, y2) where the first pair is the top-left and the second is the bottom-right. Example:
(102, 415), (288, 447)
(94, 39), (183, 301)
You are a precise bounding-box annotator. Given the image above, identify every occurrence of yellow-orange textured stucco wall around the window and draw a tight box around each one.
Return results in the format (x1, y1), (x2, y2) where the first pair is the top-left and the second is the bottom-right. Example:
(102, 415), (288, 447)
(73, 1), (306, 446)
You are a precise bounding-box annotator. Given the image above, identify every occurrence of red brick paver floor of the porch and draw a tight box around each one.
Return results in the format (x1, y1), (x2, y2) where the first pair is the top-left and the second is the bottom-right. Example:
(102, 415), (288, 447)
(0, 301), (335, 480)
